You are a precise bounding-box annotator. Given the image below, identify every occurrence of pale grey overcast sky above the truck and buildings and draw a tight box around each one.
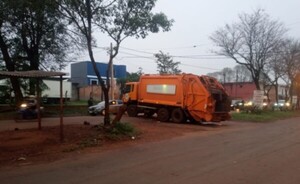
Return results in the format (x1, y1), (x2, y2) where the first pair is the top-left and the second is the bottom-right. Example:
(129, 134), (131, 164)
(67, 0), (300, 75)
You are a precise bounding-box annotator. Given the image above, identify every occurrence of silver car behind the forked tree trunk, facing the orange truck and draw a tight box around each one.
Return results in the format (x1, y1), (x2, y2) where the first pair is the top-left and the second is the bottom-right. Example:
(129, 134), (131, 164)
(88, 100), (123, 115)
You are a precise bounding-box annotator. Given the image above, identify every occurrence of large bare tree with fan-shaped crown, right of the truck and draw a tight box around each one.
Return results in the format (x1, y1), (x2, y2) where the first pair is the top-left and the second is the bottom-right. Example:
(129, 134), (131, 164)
(210, 9), (286, 89)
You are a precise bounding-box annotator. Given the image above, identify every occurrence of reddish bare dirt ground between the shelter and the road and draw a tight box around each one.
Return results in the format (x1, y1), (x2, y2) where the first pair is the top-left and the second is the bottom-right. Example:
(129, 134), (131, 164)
(0, 117), (218, 168)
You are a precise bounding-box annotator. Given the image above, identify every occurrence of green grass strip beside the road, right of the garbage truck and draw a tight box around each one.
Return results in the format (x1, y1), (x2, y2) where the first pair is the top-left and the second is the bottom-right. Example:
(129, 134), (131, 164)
(231, 111), (300, 122)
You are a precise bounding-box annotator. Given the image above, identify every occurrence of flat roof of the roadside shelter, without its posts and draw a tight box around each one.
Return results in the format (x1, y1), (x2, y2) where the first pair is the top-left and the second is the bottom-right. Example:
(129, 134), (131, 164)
(0, 70), (66, 78)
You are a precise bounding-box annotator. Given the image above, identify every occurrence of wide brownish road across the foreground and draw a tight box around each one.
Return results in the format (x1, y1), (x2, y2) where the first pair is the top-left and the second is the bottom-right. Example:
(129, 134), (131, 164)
(0, 118), (300, 184)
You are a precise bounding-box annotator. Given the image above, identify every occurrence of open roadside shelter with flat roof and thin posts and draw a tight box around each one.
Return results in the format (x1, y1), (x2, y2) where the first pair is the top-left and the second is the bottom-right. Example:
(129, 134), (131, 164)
(0, 70), (66, 141)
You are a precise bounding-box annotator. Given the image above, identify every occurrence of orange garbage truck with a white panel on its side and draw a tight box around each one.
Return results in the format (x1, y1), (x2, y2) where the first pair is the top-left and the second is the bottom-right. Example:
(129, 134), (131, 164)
(123, 74), (231, 123)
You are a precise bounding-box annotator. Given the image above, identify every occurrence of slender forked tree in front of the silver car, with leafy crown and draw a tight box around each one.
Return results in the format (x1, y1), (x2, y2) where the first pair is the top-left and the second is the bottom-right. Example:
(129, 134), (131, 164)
(57, 0), (173, 125)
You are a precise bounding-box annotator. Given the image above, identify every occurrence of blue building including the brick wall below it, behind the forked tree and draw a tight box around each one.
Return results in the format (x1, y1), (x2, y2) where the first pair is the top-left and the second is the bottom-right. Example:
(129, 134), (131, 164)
(71, 61), (127, 101)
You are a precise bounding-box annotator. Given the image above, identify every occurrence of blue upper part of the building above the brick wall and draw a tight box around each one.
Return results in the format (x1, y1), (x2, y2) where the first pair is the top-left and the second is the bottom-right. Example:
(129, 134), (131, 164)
(71, 61), (126, 87)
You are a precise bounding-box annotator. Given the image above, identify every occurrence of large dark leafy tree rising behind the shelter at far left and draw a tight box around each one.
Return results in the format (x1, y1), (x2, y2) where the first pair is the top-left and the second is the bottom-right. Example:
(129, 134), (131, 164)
(0, 0), (72, 101)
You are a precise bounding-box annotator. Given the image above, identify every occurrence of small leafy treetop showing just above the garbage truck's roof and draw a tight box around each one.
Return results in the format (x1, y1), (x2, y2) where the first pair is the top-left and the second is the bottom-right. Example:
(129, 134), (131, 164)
(154, 51), (181, 74)
